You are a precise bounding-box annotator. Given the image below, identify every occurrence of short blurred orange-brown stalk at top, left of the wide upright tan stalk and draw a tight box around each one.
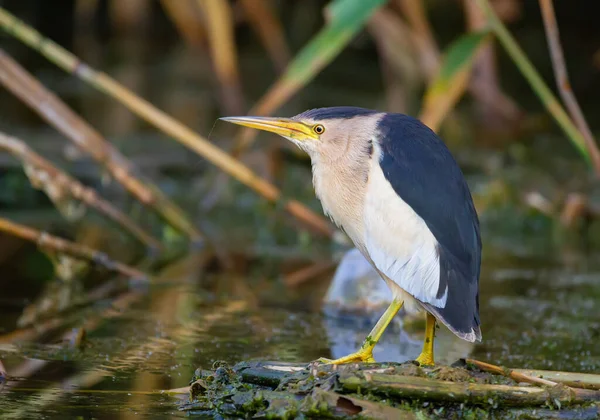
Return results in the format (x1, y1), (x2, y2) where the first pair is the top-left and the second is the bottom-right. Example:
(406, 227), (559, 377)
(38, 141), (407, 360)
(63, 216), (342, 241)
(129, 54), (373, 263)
(161, 0), (206, 47)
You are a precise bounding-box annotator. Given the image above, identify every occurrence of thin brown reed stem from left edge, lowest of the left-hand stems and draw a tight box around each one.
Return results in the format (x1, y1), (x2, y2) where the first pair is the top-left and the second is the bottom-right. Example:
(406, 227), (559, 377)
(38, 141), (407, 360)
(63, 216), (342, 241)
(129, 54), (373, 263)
(0, 218), (148, 280)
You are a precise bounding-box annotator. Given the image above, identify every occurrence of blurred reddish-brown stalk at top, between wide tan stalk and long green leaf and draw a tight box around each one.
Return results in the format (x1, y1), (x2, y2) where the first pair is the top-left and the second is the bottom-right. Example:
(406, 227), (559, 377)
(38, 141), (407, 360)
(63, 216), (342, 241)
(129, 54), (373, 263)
(240, 0), (291, 73)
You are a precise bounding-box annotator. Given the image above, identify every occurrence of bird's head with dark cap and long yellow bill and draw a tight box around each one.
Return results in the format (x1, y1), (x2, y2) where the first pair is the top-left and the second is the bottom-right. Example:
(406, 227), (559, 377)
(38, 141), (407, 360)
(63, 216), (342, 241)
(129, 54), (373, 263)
(221, 107), (381, 159)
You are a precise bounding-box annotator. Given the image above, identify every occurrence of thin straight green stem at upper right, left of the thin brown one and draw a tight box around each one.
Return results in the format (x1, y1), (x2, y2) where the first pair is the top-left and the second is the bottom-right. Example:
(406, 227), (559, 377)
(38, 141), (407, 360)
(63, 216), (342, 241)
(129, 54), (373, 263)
(474, 0), (591, 167)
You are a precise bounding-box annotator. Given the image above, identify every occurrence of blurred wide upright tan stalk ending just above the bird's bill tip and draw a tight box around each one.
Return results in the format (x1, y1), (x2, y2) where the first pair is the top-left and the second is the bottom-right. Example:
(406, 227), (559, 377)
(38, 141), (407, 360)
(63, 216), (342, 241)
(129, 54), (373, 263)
(196, 0), (244, 114)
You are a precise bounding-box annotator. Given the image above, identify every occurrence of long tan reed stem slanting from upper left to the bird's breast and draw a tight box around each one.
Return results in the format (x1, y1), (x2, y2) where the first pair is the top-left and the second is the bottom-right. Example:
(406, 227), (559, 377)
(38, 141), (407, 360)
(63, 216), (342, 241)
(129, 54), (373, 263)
(0, 7), (334, 236)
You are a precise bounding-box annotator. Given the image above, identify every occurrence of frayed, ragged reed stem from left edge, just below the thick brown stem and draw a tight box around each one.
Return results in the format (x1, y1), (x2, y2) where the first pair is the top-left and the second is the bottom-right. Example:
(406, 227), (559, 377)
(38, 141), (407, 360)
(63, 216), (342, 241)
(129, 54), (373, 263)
(0, 132), (161, 250)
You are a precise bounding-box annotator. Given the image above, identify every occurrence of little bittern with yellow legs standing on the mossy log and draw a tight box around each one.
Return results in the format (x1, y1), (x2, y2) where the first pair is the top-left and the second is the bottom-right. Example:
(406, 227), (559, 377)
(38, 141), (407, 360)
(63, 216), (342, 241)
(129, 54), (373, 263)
(222, 107), (481, 365)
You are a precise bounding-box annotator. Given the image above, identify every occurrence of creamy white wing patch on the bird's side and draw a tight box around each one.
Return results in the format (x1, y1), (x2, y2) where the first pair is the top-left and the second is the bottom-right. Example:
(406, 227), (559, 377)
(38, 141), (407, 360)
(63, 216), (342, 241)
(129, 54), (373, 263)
(363, 150), (448, 308)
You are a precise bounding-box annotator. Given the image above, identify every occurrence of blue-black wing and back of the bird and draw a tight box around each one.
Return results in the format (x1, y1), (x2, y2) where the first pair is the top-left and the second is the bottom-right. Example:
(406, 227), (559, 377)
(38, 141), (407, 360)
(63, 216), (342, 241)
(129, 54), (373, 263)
(379, 114), (481, 341)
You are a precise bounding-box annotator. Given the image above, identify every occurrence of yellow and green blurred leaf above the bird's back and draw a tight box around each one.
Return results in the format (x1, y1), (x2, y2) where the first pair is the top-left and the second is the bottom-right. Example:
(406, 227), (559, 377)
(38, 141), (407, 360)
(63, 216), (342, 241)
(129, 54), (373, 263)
(420, 30), (490, 131)
